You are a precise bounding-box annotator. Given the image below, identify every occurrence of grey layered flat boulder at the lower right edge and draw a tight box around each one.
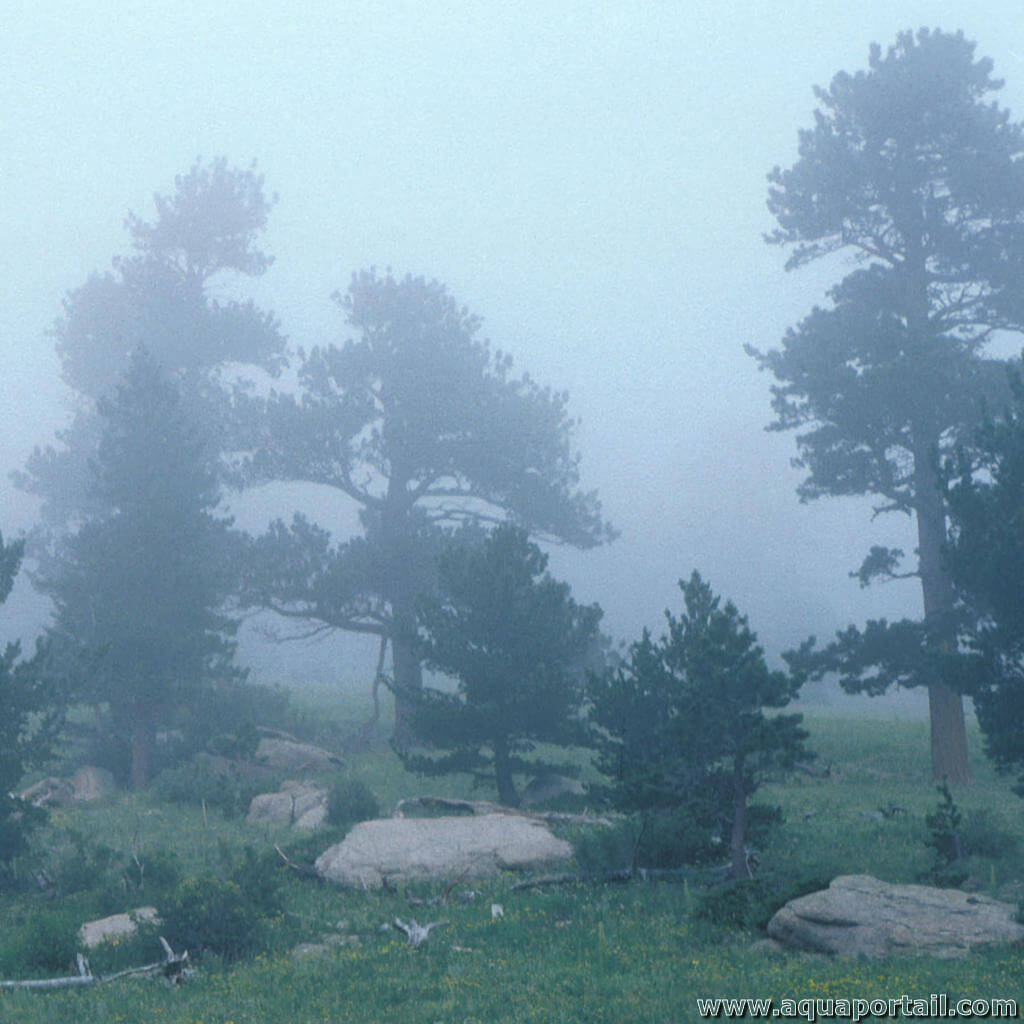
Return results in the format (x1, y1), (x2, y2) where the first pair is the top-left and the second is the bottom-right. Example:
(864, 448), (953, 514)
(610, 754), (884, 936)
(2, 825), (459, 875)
(768, 874), (1024, 958)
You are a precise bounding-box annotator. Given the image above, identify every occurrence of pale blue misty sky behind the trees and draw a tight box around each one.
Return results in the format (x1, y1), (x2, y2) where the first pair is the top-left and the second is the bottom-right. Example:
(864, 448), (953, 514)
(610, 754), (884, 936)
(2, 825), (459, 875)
(0, 0), (1024, 688)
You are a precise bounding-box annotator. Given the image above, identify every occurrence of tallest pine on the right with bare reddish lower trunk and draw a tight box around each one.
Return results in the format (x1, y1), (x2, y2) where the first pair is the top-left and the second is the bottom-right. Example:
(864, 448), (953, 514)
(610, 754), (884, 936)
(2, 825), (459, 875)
(748, 29), (1024, 781)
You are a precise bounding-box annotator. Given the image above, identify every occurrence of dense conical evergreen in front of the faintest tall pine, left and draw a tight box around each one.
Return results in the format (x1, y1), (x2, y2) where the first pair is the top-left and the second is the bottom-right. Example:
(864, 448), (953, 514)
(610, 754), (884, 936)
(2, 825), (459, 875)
(39, 351), (242, 786)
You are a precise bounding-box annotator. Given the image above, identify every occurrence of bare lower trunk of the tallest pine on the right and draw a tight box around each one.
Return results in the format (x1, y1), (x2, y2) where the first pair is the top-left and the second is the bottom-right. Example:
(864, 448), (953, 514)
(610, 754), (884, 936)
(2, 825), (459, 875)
(914, 440), (971, 784)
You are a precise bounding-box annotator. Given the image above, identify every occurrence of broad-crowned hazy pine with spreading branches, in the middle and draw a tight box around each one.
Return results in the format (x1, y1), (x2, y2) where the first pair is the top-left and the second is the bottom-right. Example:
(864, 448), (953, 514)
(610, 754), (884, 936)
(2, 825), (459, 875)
(235, 270), (613, 743)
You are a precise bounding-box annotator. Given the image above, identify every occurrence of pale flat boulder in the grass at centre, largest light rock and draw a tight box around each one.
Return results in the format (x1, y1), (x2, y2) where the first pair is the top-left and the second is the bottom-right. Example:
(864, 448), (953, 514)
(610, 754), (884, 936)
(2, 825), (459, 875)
(316, 814), (572, 887)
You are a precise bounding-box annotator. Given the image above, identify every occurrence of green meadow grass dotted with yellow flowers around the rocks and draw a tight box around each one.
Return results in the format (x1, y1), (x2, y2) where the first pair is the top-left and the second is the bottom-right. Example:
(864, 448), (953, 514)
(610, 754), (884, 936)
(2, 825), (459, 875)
(0, 716), (1024, 1024)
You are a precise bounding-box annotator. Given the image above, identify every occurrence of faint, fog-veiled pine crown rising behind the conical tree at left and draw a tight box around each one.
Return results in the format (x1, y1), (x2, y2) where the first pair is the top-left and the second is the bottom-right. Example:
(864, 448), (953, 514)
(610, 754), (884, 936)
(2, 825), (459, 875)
(14, 158), (285, 534)
